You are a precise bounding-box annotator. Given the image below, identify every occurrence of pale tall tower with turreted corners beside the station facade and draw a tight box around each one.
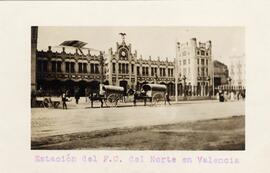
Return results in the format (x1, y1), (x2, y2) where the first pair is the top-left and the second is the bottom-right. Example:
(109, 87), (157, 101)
(176, 38), (213, 95)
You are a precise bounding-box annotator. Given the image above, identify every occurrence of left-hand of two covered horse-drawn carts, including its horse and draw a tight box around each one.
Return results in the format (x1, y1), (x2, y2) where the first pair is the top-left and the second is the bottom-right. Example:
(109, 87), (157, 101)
(89, 84), (125, 107)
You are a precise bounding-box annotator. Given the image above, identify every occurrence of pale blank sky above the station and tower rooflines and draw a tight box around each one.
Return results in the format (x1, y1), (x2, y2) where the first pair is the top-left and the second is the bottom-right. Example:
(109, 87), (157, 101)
(38, 26), (245, 64)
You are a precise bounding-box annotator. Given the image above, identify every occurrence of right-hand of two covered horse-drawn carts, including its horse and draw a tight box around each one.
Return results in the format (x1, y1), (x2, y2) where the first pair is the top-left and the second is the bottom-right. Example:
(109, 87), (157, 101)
(134, 84), (167, 105)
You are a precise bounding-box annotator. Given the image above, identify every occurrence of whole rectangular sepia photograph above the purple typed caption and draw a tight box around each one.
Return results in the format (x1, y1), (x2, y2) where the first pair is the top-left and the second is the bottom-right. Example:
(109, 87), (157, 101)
(29, 26), (246, 150)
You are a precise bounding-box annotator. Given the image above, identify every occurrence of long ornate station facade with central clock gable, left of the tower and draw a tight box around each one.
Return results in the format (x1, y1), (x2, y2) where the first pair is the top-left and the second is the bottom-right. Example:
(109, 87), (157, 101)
(35, 39), (175, 95)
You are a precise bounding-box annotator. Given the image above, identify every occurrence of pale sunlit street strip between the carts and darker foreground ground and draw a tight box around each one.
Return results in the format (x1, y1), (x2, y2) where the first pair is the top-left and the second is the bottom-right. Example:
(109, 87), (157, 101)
(31, 100), (245, 139)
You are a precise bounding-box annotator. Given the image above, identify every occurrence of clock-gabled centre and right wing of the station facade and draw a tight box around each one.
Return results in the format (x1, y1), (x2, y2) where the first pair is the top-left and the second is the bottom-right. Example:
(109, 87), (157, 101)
(105, 40), (175, 95)
